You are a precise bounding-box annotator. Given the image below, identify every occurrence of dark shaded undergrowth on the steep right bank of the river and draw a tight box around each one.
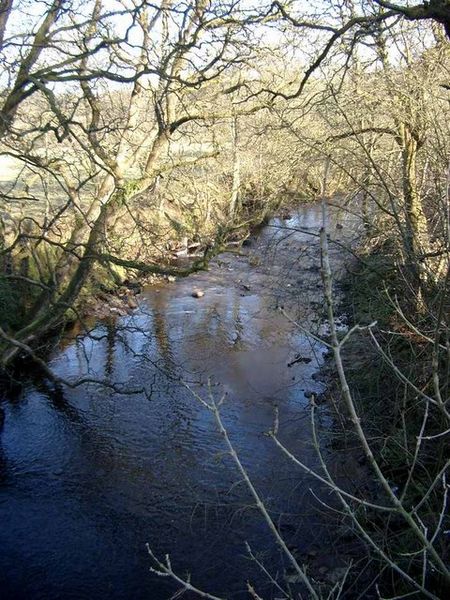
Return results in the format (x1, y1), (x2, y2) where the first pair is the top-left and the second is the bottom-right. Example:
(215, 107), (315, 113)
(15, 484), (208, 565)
(326, 239), (450, 598)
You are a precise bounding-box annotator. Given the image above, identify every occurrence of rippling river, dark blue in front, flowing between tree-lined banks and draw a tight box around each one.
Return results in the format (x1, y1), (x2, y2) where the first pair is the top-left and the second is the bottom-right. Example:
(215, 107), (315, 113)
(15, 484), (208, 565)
(0, 207), (352, 600)
